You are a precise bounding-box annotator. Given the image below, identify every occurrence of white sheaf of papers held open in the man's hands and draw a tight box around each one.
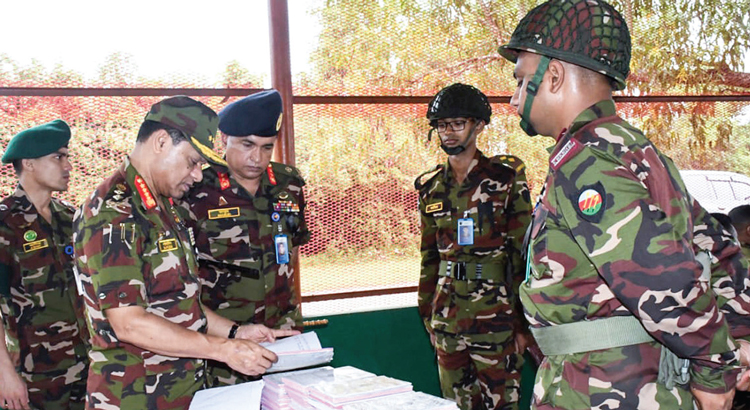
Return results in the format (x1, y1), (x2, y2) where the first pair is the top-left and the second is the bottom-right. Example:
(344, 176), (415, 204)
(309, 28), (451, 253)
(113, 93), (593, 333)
(261, 332), (333, 373)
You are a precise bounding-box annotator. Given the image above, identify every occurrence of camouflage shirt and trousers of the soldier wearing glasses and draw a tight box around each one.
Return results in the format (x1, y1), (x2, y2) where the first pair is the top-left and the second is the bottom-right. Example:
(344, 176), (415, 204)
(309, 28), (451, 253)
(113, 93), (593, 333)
(415, 151), (531, 409)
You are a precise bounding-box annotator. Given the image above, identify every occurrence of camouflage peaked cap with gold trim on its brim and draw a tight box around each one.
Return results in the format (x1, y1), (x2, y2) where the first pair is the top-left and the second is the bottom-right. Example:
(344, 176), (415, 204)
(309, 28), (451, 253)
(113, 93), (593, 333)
(144, 95), (227, 167)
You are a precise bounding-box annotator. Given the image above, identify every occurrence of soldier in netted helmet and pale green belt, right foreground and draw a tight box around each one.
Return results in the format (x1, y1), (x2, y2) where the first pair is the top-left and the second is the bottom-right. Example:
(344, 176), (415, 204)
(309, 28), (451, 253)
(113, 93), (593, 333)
(499, 0), (747, 409)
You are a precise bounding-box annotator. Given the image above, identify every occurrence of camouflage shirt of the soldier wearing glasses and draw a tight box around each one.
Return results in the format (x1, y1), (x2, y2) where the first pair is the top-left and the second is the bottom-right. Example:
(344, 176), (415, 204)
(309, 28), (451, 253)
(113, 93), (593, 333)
(416, 151), (531, 335)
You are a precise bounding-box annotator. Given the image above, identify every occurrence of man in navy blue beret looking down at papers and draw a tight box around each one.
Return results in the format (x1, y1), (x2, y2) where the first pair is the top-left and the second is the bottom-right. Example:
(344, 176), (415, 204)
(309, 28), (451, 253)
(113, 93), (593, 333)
(179, 90), (310, 386)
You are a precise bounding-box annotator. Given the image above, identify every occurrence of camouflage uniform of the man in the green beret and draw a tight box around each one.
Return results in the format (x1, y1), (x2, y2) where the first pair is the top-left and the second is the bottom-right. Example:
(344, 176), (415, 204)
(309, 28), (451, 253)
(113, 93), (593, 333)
(0, 185), (88, 409)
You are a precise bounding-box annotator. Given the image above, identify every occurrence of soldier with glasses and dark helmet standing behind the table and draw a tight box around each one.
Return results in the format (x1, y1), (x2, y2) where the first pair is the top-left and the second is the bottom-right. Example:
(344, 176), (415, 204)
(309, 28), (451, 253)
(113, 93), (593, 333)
(415, 84), (531, 409)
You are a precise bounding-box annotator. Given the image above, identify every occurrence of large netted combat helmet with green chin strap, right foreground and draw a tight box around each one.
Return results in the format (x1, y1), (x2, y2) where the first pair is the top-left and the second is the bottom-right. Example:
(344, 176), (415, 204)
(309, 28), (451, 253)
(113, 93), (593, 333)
(498, 0), (631, 135)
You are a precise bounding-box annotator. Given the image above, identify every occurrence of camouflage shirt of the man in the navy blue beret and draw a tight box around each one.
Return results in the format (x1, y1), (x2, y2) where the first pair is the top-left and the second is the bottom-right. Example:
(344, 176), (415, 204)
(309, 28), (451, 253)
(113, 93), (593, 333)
(177, 162), (310, 385)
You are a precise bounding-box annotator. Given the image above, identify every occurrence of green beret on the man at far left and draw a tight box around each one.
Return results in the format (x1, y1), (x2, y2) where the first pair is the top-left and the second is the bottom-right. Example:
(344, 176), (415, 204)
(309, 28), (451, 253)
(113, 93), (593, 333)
(2, 120), (70, 164)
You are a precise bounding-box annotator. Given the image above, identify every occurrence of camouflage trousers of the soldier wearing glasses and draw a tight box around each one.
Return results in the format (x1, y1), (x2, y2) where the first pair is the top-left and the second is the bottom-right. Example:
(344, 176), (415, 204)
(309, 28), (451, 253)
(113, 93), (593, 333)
(435, 331), (523, 410)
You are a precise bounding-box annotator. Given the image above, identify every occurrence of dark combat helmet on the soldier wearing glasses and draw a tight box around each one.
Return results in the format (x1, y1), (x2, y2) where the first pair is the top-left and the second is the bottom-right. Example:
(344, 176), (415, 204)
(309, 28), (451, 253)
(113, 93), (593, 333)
(427, 83), (492, 127)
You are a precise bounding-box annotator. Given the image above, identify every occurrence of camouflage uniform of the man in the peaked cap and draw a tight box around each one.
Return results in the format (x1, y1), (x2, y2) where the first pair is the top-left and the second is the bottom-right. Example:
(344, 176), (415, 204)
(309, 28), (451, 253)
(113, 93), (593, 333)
(74, 159), (207, 410)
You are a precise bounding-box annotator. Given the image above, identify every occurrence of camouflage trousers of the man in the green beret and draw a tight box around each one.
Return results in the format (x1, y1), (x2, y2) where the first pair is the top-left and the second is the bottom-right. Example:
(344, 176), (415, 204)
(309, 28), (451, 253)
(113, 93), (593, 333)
(21, 363), (86, 410)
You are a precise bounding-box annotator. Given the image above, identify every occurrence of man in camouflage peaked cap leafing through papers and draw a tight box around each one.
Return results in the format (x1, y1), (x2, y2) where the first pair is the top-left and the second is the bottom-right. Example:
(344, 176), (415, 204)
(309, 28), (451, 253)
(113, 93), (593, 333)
(74, 96), (290, 409)
